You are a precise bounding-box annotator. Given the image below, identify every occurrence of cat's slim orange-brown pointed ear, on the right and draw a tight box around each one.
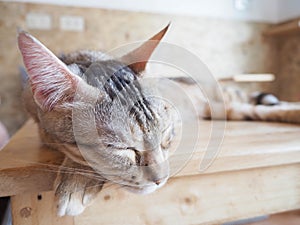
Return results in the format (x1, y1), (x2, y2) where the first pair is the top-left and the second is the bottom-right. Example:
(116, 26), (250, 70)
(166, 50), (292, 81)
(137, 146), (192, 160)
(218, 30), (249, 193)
(121, 24), (170, 74)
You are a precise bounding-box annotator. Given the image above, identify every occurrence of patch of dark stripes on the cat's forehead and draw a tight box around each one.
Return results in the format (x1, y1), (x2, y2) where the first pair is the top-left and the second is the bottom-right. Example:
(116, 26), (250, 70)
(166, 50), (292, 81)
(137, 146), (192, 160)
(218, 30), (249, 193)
(85, 60), (155, 130)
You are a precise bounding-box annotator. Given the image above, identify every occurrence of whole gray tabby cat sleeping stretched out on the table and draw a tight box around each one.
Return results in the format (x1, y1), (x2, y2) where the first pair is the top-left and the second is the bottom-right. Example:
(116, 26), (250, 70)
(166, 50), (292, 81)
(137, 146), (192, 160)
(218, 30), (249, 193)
(18, 24), (300, 216)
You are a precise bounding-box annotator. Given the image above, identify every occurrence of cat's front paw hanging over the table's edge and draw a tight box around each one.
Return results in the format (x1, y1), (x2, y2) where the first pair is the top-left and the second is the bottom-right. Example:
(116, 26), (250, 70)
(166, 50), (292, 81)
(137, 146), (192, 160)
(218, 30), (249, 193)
(54, 157), (105, 216)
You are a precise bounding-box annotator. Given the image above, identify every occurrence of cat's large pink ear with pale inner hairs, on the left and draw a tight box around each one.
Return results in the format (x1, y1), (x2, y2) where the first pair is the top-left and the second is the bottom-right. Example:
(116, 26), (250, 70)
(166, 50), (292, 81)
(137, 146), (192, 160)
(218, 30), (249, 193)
(18, 31), (81, 111)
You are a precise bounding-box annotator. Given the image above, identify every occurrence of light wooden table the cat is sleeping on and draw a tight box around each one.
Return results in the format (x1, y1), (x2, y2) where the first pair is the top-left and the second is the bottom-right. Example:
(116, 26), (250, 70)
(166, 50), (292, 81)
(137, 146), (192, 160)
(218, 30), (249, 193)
(0, 120), (300, 225)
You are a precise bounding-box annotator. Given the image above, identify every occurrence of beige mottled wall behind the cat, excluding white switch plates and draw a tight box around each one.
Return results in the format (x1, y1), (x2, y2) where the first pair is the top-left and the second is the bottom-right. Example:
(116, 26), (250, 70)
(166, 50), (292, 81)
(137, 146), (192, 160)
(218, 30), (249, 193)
(0, 2), (278, 133)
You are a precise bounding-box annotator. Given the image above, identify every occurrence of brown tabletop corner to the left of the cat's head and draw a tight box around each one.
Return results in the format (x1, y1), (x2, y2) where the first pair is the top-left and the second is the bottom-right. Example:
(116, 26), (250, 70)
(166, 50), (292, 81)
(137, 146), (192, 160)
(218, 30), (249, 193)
(0, 120), (63, 196)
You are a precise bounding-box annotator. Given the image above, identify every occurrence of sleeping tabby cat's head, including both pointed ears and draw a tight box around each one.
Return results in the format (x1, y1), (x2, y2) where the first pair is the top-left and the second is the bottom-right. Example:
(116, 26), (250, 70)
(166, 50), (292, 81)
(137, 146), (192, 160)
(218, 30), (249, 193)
(18, 24), (173, 193)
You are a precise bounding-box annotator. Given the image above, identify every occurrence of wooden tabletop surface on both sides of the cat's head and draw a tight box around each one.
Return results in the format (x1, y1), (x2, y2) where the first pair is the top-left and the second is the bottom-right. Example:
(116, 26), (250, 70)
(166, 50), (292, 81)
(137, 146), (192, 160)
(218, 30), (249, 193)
(0, 120), (300, 196)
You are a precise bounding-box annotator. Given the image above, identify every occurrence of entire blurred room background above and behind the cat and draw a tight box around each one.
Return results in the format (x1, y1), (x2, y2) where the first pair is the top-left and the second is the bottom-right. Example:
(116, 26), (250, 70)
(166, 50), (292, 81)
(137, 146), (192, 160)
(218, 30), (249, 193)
(0, 0), (300, 135)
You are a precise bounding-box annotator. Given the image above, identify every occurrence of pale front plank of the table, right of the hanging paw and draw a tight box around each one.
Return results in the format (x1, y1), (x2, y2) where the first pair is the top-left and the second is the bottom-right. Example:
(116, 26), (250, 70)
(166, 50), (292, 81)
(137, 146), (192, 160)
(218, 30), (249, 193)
(74, 164), (300, 225)
